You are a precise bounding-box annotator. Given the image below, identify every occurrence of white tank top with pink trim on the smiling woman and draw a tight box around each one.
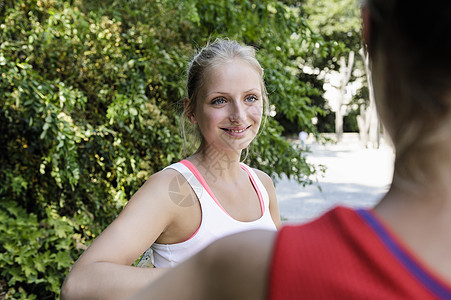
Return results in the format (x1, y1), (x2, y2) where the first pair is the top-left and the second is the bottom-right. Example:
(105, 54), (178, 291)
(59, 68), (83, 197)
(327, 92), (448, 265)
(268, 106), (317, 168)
(138, 160), (276, 268)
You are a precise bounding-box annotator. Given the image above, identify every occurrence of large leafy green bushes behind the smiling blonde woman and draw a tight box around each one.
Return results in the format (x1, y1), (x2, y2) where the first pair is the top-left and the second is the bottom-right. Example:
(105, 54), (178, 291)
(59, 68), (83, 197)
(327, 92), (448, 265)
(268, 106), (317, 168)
(0, 0), (334, 299)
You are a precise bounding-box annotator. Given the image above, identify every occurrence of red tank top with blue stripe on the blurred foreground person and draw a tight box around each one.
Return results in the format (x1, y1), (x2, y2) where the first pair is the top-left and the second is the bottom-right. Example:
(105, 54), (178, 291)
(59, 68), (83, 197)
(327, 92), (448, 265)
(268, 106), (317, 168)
(268, 207), (451, 300)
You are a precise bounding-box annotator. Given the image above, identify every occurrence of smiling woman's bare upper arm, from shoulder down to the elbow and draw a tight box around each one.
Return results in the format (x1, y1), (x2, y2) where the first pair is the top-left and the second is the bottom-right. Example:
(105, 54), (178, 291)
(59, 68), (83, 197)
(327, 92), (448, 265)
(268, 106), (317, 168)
(69, 169), (194, 266)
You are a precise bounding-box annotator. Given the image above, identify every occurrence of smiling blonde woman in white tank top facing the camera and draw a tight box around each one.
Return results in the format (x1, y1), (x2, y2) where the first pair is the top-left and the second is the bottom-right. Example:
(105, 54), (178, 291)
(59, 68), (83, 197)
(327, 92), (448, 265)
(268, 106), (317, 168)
(61, 39), (281, 299)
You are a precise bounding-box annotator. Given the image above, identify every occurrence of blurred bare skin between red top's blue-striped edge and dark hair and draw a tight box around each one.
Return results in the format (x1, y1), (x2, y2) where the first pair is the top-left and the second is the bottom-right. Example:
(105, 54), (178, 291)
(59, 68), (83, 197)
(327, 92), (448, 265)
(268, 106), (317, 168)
(375, 175), (451, 283)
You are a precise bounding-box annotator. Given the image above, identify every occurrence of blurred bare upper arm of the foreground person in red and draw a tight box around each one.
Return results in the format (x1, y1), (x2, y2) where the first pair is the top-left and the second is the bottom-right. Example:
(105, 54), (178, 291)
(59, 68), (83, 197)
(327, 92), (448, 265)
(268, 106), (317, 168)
(130, 230), (276, 300)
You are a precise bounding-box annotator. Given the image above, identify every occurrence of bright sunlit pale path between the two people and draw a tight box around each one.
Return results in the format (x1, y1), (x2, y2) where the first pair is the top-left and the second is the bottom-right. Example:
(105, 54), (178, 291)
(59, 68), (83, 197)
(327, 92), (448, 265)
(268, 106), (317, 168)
(276, 138), (393, 223)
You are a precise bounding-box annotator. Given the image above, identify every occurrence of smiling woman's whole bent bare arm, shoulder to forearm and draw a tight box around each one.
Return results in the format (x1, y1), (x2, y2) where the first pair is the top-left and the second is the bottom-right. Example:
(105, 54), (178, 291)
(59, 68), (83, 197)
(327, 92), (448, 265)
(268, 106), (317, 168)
(61, 172), (192, 299)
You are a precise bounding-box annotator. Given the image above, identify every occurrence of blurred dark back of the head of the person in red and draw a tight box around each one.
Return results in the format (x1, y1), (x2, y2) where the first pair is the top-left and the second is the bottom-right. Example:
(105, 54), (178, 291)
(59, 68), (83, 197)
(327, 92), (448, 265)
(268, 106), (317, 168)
(366, 0), (451, 188)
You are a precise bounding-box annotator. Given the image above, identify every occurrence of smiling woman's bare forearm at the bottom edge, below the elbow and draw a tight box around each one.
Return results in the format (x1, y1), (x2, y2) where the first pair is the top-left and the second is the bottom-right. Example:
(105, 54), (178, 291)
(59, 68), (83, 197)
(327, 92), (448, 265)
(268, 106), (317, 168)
(61, 262), (167, 300)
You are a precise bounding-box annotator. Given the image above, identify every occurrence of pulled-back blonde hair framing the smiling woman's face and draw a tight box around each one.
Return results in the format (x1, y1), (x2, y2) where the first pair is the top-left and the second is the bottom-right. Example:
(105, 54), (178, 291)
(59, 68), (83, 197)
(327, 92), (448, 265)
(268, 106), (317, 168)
(181, 38), (269, 155)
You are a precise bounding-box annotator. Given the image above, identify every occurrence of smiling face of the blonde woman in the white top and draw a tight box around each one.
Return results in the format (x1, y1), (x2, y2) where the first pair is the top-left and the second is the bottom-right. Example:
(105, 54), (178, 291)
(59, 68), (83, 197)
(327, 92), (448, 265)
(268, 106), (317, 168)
(190, 59), (263, 152)
